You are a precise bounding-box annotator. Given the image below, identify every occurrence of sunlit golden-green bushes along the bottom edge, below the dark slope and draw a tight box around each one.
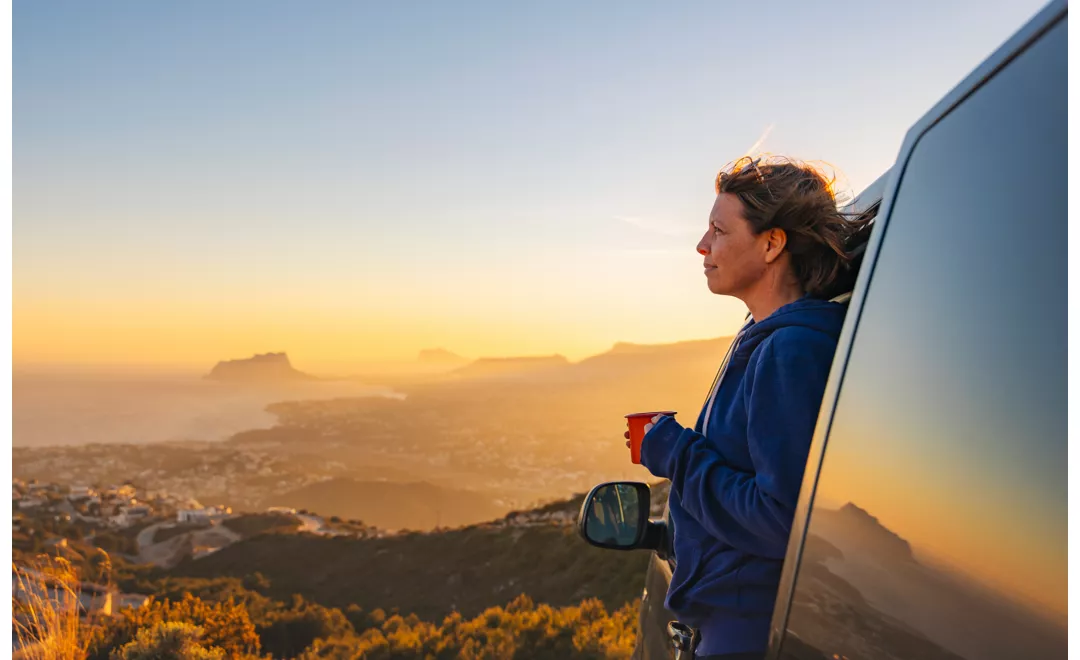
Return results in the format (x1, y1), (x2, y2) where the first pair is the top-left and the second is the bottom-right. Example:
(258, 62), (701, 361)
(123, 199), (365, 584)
(86, 585), (637, 660)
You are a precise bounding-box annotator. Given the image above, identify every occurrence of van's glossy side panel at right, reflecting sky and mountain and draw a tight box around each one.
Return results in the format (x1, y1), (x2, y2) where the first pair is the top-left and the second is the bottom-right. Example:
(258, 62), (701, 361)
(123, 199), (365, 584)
(770, 5), (1068, 660)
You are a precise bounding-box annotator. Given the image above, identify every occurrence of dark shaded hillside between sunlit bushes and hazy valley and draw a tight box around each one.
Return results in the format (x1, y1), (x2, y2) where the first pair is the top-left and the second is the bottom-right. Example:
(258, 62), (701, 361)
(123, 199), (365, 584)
(168, 496), (650, 621)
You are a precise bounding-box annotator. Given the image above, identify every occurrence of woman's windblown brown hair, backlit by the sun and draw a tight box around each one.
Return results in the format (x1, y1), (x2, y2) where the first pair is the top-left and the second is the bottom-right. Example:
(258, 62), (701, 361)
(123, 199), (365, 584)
(716, 157), (873, 297)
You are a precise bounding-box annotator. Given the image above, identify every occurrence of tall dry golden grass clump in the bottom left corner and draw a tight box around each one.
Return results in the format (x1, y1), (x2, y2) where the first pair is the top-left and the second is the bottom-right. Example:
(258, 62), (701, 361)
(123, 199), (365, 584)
(12, 553), (108, 660)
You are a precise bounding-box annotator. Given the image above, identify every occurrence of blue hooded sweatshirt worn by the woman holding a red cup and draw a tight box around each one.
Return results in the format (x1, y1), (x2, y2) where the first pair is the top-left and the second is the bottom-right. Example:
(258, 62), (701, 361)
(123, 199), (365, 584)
(642, 297), (847, 655)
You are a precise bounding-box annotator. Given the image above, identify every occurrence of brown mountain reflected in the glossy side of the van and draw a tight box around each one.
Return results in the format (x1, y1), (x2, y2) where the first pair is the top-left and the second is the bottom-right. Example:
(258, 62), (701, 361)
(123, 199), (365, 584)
(792, 502), (1066, 660)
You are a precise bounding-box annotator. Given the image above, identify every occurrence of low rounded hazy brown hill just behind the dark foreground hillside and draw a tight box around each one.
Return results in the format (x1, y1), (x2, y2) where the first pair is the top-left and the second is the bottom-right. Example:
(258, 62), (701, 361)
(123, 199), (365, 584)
(261, 479), (507, 529)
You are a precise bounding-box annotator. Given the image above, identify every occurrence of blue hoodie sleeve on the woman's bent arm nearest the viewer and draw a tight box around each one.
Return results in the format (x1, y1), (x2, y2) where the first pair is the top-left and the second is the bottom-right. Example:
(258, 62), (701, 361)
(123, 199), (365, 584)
(642, 327), (836, 558)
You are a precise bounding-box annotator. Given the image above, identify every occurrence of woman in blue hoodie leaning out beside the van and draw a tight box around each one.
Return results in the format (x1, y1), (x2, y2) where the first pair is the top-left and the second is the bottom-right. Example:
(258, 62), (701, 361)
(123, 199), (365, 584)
(642, 158), (869, 660)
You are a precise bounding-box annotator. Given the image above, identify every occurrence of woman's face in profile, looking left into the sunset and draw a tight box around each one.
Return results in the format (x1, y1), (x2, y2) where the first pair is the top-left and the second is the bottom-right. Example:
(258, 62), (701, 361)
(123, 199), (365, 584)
(698, 192), (769, 297)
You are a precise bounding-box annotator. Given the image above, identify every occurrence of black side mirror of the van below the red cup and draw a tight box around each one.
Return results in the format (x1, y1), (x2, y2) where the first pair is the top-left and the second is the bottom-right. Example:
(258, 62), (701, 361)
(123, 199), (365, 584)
(578, 482), (662, 550)
